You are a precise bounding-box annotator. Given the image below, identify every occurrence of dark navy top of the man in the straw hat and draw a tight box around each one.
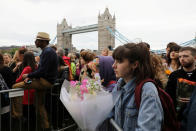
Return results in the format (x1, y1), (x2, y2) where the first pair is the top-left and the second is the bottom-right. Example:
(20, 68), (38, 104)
(28, 47), (58, 84)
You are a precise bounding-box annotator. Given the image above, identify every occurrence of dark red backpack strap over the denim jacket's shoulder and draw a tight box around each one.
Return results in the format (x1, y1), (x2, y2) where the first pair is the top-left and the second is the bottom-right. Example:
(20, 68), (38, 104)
(135, 78), (156, 110)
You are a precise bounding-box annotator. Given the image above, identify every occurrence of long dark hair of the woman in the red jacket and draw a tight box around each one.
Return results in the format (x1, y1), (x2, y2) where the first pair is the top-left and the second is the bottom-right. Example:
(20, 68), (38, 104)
(22, 51), (36, 71)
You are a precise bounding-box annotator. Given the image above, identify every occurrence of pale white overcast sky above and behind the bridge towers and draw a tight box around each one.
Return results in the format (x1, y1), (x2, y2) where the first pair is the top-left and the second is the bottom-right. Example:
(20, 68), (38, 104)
(0, 0), (196, 49)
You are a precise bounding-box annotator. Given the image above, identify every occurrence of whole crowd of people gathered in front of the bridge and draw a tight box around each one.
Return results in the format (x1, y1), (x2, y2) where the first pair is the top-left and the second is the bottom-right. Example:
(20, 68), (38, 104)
(0, 32), (196, 131)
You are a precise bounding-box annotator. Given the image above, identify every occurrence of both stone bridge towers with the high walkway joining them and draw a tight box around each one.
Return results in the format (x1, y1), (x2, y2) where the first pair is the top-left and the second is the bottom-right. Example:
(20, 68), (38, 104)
(57, 8), (116, 52)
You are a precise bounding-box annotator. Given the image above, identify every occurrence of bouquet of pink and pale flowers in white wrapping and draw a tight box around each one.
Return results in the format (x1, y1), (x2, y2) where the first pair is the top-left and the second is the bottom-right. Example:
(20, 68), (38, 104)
(60, 75), (120, 131)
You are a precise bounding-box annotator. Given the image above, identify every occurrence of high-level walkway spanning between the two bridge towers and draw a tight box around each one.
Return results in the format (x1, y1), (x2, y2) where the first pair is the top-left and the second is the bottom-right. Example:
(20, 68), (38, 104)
(62, 24), (98, 34)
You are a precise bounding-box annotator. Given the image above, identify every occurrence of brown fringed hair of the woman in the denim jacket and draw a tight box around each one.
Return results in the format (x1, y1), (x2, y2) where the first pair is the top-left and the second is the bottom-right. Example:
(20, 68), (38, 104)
(112, 43), (155, 84)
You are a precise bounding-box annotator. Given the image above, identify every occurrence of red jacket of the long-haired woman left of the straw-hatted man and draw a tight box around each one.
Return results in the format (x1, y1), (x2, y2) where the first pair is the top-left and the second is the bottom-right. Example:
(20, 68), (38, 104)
(16, 66), (35, 105)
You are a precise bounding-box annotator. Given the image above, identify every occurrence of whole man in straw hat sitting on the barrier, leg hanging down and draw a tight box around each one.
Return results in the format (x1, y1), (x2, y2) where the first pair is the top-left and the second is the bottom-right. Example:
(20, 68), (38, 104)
(13, 32), (58, 129)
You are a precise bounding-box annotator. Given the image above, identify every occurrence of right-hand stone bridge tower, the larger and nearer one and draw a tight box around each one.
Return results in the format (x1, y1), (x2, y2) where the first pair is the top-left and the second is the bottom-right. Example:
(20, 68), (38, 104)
(98, 8), (116, 51)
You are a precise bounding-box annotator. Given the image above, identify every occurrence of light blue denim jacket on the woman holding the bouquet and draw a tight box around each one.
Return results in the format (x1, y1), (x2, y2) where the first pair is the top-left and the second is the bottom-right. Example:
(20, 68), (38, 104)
(113, 78), (164, 131)
